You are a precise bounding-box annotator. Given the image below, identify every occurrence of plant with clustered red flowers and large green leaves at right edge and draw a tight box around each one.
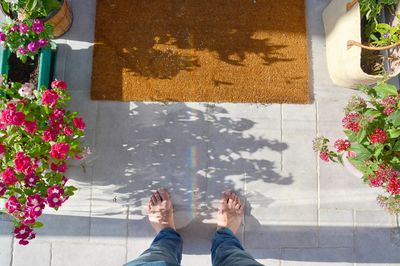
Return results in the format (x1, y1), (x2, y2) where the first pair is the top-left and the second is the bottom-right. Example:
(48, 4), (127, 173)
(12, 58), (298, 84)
(314, 82), (400, 214)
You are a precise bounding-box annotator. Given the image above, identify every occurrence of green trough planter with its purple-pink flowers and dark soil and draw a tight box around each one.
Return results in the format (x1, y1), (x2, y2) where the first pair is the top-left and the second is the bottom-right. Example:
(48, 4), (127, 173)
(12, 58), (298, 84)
(0, 19), (56, 88)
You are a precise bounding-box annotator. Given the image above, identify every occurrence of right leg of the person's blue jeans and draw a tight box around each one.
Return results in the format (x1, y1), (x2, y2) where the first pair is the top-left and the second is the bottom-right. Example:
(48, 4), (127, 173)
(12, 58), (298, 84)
(211, 228), (262, 266)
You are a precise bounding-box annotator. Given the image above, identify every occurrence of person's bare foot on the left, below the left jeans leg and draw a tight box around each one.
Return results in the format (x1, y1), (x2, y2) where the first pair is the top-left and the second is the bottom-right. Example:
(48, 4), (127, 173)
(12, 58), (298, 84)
(148, 188), (176, 233)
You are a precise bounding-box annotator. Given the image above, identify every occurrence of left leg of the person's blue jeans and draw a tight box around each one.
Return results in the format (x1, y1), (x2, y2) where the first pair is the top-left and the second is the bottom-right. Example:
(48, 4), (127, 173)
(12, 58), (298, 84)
(125, 228), (182, 266)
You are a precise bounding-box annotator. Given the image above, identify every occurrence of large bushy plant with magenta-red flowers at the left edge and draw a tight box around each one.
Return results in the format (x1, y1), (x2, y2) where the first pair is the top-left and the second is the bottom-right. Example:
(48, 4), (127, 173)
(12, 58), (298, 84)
(0, 76), (85, 245)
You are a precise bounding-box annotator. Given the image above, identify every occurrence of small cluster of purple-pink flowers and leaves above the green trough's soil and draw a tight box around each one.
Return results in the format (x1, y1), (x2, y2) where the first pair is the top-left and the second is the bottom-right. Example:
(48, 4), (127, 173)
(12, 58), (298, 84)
(0, 19), (52, 63)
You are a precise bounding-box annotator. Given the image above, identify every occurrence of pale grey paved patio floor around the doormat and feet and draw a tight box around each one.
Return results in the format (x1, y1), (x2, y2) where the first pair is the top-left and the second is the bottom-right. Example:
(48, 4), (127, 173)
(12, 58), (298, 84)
(0, 0), (400, 266)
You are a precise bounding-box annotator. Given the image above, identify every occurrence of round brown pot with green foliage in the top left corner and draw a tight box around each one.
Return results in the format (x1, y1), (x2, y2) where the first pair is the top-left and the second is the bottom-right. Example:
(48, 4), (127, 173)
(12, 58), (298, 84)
(1, 0), (73, 38)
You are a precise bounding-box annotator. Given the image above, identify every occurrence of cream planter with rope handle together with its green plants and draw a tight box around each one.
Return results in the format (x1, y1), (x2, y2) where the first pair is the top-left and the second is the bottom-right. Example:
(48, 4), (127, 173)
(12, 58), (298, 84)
(323, 0), (400, 87)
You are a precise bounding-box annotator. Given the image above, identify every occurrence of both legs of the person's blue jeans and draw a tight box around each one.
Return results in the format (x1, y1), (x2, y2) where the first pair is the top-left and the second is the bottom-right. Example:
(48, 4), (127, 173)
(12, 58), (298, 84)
(126, 228), (262, 266)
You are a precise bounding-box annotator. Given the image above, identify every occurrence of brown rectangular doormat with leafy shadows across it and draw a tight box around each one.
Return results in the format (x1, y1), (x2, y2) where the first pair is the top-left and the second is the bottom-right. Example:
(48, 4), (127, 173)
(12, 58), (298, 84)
(92, 0), (310, 103)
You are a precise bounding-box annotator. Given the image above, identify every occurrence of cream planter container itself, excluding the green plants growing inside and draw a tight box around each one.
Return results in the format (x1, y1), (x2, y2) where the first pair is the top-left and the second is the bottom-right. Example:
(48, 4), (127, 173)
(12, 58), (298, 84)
(322, 0), (400, 87)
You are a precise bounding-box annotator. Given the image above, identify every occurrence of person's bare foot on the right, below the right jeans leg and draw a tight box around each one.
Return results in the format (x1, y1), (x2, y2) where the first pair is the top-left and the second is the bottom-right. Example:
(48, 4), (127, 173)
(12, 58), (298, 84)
(217, 191), (244, 234)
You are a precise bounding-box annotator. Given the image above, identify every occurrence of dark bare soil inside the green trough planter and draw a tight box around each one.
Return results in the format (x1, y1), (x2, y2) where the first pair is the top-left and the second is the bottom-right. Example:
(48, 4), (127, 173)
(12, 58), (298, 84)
(8, 53), (39, 84)
